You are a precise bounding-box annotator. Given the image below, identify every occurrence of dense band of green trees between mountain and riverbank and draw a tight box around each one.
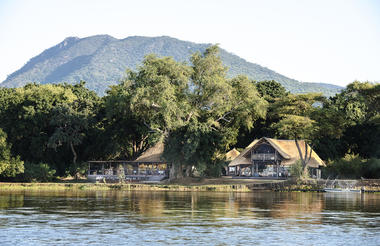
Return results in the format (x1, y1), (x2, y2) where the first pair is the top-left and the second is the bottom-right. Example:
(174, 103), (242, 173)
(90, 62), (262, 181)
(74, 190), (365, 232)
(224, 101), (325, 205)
(0, 46), (380, 181)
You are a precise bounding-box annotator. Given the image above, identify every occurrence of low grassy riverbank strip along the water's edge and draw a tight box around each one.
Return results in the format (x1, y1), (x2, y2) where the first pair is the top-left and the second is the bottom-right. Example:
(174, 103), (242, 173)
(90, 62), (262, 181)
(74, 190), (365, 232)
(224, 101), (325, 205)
(0, 177), (380, 192)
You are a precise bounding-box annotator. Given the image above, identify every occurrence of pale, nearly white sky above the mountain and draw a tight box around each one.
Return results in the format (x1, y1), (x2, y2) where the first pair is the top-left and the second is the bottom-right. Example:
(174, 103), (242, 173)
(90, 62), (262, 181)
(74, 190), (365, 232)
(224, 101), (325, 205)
(0, 0), (380, 86)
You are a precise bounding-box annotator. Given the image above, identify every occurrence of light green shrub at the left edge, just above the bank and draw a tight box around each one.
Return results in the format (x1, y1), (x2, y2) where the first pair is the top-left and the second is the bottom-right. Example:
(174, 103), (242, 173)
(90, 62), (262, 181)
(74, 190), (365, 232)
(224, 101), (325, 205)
(0, 128), (24, 177)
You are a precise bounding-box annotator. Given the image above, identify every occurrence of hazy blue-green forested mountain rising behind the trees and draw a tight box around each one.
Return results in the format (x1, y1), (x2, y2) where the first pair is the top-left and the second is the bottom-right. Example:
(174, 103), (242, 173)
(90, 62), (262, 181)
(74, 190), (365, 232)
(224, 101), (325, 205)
(0, 35), (341, 96)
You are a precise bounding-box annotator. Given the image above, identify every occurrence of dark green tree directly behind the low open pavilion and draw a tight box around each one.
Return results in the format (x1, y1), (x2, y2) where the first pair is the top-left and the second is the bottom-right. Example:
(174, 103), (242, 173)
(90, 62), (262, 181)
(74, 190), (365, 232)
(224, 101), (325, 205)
(101, 78), (160, 159)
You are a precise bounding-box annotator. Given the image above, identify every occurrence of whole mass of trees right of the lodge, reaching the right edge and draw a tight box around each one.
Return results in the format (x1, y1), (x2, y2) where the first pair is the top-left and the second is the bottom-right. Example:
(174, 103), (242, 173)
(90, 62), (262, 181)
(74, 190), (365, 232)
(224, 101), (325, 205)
(313, 81), (380, 159)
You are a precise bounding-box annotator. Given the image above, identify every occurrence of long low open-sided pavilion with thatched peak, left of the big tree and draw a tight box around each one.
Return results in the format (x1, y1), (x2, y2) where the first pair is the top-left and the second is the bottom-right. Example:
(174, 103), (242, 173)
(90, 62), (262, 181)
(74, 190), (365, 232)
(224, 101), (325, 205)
(87, 142), (169, 182)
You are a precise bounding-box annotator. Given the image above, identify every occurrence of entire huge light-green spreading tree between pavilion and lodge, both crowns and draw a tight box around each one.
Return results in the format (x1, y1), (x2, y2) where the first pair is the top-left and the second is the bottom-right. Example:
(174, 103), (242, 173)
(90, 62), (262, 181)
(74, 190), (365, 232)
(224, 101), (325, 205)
(111, 46), (266, 177)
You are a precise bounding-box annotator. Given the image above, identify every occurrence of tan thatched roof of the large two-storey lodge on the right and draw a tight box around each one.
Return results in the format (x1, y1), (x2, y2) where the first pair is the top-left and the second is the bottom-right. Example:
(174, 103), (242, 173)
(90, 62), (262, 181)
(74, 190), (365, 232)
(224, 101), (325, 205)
(229, 138), (325, 167)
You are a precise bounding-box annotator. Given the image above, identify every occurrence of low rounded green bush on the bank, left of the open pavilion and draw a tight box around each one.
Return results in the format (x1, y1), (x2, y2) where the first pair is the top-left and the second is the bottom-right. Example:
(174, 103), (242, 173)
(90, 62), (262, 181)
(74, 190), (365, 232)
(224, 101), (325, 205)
(23, 163), (56, 182)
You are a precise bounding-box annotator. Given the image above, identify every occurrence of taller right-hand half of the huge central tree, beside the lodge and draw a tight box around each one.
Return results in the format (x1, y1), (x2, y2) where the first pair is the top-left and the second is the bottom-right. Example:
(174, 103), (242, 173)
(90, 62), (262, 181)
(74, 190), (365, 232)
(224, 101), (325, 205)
(165, 46), (266, 176)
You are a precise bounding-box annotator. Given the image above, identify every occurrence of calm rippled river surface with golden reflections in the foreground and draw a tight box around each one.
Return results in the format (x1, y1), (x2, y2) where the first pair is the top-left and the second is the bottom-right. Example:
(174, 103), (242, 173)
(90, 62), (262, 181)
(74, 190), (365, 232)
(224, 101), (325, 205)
(0, 191), (380, 246)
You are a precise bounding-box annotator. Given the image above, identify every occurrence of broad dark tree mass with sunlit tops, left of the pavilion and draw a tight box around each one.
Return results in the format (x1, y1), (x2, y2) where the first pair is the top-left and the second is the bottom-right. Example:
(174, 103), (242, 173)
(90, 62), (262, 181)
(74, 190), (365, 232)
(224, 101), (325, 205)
(0, 82), (100, 175)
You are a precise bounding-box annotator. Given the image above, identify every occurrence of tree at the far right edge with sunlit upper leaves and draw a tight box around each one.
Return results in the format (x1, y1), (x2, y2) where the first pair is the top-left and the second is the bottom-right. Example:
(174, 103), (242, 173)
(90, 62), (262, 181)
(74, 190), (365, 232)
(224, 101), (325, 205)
(329, 81), (380, 158)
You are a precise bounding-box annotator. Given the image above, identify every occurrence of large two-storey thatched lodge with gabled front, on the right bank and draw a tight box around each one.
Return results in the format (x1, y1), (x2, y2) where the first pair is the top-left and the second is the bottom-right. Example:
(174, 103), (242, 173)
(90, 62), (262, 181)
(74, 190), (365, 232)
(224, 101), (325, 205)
(228, 138), (325, 178)
